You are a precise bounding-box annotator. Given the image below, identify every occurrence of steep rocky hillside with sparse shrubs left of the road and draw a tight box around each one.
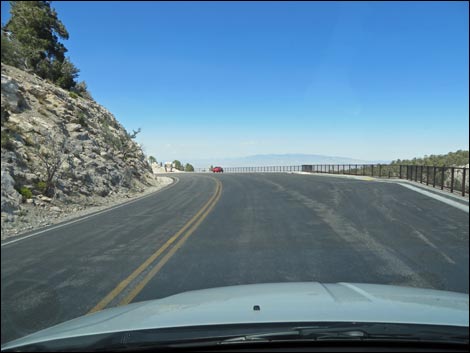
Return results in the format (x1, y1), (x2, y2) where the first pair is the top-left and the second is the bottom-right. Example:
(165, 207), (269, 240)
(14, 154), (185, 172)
(1, 63), (155, 232)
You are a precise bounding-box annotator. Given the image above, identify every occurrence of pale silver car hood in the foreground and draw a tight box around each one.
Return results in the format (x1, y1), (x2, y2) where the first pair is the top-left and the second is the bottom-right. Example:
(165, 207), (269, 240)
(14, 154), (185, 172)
(2, 282), (469, 349)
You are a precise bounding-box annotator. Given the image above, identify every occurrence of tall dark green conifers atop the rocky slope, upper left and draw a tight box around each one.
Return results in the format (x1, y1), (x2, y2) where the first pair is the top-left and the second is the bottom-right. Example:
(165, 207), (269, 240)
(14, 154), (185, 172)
(1, 1), (92, 99)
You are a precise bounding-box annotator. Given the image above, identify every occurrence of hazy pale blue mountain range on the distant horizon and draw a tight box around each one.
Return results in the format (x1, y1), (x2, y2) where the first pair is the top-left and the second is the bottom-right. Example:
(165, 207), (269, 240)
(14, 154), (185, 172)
(191, 154), (390, 168)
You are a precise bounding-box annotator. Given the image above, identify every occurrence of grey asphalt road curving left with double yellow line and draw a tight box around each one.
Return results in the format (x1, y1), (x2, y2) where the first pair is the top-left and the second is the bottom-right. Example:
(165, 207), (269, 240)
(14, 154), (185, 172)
(1, 173), (469, 343)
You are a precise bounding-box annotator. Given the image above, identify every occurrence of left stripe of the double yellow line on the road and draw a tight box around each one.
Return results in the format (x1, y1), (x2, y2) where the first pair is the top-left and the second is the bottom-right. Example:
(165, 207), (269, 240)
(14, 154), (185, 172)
(88, 179), (222, 314)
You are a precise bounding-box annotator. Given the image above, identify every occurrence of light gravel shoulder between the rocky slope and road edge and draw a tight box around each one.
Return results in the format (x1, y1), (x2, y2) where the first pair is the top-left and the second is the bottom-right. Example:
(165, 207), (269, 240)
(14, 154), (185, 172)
(1, 176), (174, 240)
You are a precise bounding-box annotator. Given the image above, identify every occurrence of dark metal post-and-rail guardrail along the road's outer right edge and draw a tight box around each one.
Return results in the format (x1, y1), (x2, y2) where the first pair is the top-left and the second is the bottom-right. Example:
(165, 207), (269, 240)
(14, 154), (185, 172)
(196, 164), (470, 196)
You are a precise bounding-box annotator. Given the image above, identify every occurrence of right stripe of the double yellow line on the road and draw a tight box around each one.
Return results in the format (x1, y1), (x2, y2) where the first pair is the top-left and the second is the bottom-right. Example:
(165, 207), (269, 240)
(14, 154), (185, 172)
(119, 181), (222, 305)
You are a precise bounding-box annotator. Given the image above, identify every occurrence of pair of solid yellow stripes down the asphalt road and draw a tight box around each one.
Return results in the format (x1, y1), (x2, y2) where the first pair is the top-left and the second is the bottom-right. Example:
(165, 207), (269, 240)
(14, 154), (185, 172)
(88, 178), (222, 314)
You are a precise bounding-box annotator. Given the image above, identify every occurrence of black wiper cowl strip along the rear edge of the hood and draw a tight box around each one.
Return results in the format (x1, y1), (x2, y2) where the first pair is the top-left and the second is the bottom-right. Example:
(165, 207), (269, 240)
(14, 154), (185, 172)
(6, 322), (469, 352)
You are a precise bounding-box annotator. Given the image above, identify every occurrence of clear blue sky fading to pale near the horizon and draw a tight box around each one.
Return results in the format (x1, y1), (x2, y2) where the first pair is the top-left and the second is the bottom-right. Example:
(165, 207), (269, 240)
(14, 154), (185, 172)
(2, 1), (469, 162)
